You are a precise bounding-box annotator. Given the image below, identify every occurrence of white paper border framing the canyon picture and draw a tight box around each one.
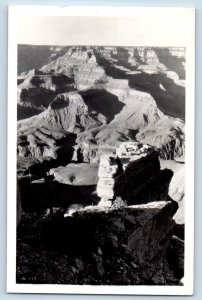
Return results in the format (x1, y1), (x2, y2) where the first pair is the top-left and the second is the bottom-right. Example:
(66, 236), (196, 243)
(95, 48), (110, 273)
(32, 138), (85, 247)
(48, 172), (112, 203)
(7, 5), (195, 295)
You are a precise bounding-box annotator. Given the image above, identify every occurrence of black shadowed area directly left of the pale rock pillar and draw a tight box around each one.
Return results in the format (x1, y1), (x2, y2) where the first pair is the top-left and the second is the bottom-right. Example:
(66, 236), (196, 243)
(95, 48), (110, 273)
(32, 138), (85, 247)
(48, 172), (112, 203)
(19, 176), (99, 213)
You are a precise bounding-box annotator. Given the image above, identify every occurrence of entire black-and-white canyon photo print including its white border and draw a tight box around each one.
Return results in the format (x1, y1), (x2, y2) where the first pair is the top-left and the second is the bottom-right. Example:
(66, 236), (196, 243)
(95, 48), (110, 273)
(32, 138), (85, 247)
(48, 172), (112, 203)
(7, 6), (194, 294)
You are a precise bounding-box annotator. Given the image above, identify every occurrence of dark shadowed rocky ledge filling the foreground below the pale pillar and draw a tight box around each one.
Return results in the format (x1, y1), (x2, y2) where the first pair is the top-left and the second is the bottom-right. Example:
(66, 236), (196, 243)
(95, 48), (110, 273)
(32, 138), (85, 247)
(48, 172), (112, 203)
(16, 201), (183, 285)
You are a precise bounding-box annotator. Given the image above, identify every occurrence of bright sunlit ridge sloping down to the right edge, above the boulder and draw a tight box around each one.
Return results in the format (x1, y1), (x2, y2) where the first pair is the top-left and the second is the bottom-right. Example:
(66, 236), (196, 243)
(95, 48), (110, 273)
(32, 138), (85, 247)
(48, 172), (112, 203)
(110, 84), (185, 160)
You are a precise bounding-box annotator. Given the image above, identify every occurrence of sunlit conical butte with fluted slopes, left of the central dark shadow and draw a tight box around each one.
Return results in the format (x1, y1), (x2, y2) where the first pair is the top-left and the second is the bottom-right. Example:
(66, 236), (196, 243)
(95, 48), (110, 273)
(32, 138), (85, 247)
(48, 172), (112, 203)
(18, 92), (113, 133)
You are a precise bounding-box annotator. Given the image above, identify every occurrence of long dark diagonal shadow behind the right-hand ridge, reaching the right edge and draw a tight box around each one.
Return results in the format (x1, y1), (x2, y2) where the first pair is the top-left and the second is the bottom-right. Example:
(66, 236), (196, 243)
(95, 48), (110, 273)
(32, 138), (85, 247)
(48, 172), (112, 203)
(96, 52), (185, 120)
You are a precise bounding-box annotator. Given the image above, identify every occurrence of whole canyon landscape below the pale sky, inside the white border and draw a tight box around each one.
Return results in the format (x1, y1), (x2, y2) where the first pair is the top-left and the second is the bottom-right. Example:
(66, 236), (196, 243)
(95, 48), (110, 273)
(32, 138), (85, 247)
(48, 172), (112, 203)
(17, 45), (186, 285)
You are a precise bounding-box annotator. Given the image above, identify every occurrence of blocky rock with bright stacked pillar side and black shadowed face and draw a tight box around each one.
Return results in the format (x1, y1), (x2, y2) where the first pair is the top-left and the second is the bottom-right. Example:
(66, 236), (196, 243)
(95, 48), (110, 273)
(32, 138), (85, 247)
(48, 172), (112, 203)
(97, 142), (173, 206)
